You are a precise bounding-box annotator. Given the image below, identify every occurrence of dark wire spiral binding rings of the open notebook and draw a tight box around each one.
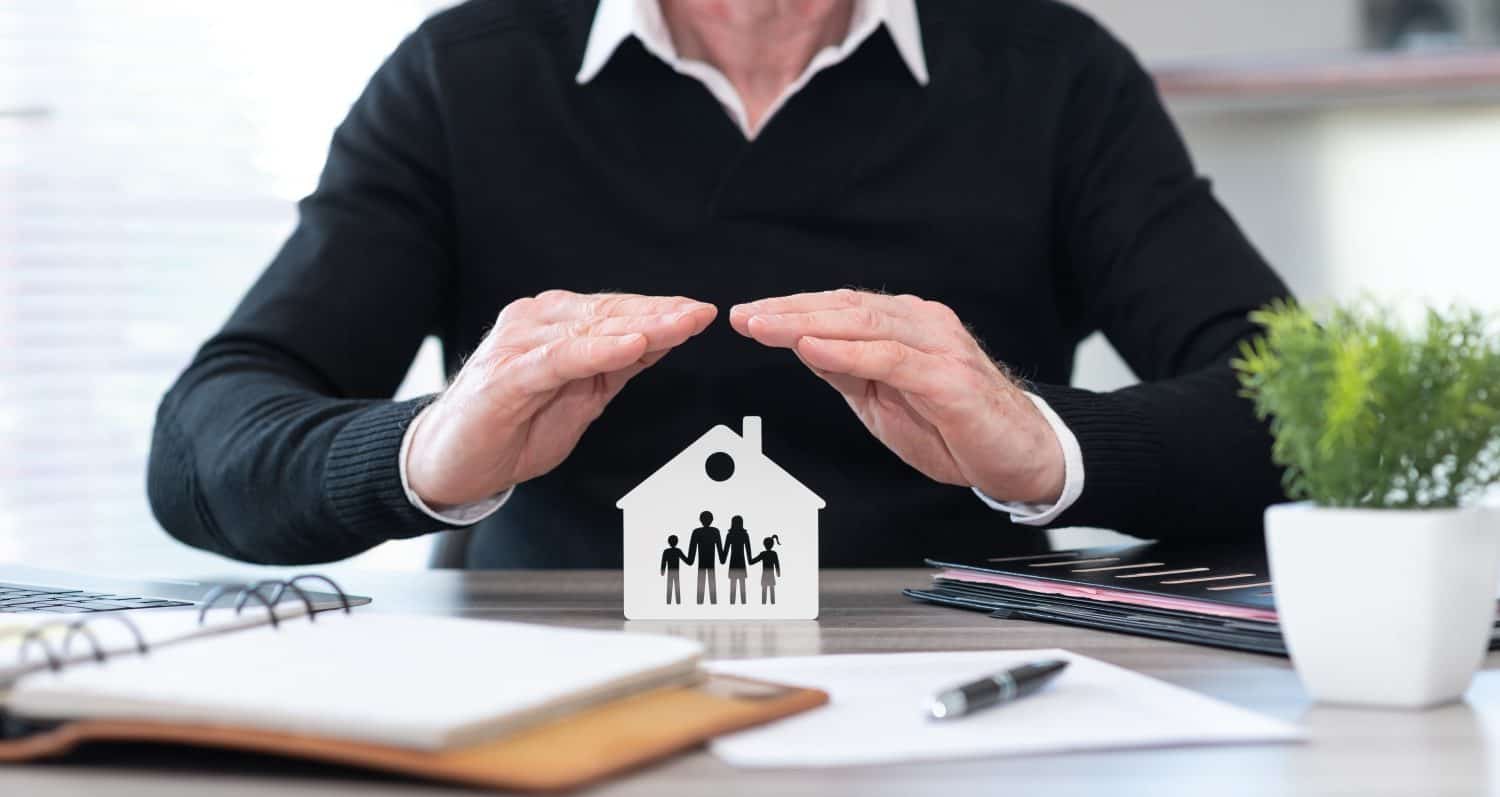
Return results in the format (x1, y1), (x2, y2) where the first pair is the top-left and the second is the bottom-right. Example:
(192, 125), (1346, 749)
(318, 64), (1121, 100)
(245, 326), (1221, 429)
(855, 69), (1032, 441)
(0, 573), (354, 672)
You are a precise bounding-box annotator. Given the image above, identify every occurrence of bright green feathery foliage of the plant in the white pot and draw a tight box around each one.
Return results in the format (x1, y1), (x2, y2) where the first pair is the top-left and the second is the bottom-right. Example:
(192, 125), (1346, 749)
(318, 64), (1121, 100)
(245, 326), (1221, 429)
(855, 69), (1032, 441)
(1230, 300), (1500, 507)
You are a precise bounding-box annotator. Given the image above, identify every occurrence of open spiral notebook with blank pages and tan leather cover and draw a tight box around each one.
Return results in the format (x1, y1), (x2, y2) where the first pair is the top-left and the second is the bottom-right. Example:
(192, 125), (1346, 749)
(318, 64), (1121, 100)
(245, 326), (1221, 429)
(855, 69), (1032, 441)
(0, 576), (827, 789)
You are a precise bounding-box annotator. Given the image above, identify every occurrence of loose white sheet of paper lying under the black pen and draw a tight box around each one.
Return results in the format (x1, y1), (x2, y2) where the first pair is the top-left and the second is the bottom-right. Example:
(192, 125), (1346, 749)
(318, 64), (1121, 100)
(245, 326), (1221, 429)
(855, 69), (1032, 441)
(708, 650), (1302, 767)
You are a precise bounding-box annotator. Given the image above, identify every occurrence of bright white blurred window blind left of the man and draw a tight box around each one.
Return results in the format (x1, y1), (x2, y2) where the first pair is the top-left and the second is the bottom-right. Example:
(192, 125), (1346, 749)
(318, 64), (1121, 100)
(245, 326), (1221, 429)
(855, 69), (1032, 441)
(0, 0), (453, 573)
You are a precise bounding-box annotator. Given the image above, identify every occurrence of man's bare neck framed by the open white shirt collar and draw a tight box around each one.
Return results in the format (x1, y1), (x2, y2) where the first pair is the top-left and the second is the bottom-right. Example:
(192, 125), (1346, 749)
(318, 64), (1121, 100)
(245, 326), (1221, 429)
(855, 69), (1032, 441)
(662, 0), (854, 129)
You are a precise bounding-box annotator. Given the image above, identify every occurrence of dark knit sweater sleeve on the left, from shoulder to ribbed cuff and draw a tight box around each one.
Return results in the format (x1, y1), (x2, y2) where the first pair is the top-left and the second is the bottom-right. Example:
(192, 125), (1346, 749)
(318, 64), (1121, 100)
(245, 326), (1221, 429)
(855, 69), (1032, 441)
(147, 32), (465, 564)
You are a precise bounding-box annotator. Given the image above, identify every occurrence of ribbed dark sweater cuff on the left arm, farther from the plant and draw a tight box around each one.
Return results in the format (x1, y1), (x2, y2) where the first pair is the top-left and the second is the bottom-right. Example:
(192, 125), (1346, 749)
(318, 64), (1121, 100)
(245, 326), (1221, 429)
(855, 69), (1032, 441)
(323, 396), (459, 540)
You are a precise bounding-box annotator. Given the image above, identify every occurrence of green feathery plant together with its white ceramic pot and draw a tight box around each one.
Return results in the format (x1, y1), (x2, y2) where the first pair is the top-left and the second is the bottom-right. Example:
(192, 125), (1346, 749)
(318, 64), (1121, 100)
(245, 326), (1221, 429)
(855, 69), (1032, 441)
(1233, 302), (1500, 708)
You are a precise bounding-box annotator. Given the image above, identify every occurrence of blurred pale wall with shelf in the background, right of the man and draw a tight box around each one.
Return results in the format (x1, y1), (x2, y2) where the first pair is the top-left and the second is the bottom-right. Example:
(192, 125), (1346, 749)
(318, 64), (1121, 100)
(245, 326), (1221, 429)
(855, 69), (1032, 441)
(1074, 0), (1500, 389)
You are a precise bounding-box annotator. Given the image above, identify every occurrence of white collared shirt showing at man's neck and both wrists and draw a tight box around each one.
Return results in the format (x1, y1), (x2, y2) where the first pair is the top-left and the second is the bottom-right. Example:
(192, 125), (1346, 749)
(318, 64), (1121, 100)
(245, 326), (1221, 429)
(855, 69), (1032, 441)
(398, 0), (1083, 525)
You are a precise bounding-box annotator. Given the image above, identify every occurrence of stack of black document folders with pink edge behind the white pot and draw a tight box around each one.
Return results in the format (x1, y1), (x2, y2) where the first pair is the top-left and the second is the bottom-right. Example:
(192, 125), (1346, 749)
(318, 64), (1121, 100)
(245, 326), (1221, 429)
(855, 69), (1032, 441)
(903, 542), (1500, 656)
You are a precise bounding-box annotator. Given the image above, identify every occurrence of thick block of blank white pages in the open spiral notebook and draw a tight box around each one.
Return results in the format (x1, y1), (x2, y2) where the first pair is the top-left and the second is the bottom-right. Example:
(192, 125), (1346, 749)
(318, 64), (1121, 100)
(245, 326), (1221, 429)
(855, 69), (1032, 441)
(8, 614), (702, 749)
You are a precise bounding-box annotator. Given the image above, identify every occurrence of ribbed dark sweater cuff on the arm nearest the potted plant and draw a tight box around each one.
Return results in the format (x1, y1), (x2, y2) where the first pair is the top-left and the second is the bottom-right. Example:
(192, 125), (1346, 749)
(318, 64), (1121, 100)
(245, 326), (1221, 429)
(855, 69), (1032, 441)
(1028, 384), (1163, 528)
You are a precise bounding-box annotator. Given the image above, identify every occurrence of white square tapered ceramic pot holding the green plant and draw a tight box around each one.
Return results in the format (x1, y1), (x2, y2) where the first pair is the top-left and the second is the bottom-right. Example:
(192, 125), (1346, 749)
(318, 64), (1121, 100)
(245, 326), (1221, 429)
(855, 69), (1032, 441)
(1266, 503), (1500, 708)
